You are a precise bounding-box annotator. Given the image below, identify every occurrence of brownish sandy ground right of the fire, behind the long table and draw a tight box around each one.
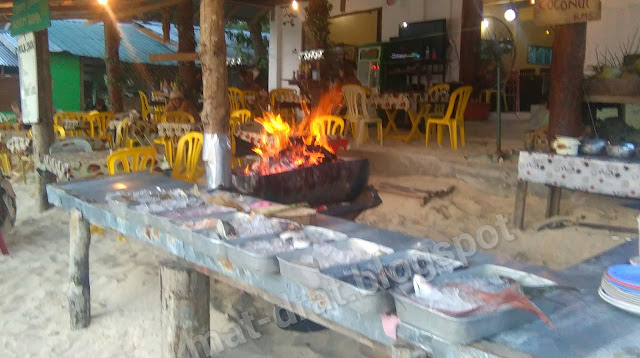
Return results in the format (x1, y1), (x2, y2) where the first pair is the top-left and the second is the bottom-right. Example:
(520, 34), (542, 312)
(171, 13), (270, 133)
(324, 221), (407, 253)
(357, 176), (640, 269)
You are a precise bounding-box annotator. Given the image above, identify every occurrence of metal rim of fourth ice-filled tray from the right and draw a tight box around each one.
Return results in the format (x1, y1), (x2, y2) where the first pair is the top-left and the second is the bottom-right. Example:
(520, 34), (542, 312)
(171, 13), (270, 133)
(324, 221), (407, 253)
(227, 226), (348, 275)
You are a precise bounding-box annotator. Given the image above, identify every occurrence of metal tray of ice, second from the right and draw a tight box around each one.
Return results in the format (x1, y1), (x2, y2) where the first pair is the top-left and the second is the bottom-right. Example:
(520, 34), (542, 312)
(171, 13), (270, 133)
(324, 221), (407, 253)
(321, 250), (464, 313)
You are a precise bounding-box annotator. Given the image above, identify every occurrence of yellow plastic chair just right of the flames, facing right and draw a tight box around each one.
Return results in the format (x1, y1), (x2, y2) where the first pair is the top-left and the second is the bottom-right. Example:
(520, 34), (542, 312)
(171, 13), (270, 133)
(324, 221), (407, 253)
(342, 85), (382, 145)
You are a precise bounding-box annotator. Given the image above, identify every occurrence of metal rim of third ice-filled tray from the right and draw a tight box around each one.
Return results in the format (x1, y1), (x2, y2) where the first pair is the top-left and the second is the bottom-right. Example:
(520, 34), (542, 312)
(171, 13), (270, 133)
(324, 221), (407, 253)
(276, 239), (393, 289)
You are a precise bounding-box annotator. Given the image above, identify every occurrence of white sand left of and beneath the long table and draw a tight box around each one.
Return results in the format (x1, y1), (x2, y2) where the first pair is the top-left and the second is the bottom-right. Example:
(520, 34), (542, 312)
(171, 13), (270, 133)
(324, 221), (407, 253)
(0, 178), (372, 358)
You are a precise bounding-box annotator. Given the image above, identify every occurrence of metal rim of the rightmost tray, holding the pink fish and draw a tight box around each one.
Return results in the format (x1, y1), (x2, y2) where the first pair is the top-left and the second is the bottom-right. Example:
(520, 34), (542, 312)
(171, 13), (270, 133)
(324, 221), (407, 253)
(392, 265), (556, 344)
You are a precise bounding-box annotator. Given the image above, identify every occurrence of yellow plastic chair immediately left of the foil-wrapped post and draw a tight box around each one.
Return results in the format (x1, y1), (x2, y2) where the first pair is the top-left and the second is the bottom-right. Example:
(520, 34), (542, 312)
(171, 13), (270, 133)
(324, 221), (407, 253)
(171, 132), (204, 183)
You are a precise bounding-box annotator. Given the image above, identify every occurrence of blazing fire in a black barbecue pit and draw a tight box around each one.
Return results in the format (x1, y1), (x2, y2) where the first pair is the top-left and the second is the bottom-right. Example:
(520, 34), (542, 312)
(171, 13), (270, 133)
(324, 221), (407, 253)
(232, 93), (379, 210)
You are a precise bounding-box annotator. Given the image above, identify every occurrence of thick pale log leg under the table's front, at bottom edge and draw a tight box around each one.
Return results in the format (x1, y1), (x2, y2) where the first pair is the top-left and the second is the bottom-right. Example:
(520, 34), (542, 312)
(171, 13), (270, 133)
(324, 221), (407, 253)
(160, 260), (211, 358)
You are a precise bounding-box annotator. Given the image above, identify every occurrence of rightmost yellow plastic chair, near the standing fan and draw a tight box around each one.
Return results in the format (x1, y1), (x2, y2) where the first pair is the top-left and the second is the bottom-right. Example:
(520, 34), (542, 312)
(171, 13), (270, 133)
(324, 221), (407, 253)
(425, 86), (473, 149)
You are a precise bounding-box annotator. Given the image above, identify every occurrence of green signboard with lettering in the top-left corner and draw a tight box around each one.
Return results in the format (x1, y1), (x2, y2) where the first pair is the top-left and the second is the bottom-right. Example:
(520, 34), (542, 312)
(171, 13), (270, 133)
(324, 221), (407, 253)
(11, 0), (51, 36)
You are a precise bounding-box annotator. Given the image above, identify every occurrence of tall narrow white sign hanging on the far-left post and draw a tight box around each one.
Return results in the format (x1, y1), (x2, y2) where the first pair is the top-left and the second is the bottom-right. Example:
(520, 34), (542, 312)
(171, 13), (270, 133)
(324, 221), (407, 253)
(18, 32), (40, 124)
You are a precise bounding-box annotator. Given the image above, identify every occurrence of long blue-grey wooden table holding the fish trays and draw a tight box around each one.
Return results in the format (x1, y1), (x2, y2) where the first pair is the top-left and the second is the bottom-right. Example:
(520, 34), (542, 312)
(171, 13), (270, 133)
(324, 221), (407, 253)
(47, 173), (640, 358)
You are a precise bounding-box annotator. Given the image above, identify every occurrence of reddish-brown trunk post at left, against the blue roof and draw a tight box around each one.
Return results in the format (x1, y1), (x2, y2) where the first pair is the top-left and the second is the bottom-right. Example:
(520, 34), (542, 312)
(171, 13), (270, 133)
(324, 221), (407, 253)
(104, 15), (123, 113)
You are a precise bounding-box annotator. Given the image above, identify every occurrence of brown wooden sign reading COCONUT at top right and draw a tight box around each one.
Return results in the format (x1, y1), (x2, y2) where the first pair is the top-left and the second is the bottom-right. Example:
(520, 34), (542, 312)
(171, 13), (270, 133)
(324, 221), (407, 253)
(533, 0), (602, 25)
